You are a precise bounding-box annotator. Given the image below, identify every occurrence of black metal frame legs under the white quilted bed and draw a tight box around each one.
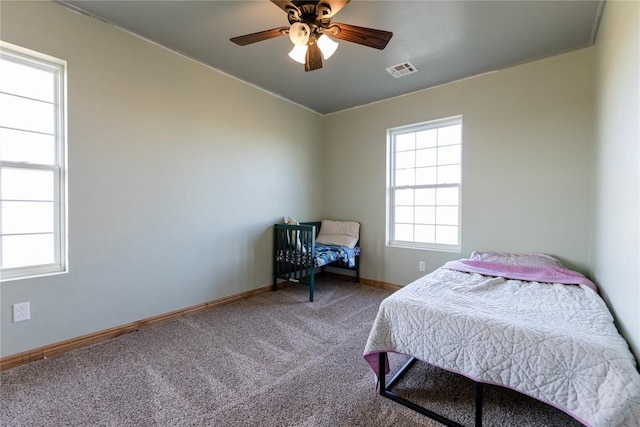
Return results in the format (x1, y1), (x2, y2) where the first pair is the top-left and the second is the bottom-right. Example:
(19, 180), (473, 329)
(378, 352), (483, 427)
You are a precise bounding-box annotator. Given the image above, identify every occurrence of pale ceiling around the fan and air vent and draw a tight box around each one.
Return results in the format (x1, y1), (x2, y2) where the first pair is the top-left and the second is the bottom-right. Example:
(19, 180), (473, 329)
(57, 0), (604, 114)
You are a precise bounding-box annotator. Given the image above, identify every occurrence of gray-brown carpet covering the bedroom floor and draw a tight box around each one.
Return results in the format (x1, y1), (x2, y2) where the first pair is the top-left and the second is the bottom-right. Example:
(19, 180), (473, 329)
(0, 278), (580, 426)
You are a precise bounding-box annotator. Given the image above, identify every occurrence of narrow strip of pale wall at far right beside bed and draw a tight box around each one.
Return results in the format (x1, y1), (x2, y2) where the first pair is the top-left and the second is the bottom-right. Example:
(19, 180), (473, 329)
(593, 1), (640, 357)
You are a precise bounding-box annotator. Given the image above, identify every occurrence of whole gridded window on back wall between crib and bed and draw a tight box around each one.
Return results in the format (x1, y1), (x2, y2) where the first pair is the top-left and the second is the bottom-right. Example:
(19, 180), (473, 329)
(388, 117), (462, 251)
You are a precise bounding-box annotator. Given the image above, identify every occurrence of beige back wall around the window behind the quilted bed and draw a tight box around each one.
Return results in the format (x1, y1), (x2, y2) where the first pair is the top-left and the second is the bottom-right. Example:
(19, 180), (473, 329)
(324, 48), (594, 284)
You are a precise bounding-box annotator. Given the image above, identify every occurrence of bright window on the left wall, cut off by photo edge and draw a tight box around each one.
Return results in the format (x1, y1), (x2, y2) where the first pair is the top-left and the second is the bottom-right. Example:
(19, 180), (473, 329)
(0, 42), (67, 281)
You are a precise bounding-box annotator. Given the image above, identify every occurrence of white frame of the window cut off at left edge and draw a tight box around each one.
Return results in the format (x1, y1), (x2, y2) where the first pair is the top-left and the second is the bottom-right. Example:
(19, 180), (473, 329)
(0, 41), (68, 282)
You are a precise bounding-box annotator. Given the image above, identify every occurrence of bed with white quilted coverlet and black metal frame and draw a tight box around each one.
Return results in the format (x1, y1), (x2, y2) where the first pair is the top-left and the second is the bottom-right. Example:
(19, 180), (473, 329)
(364, 252), (640, 427)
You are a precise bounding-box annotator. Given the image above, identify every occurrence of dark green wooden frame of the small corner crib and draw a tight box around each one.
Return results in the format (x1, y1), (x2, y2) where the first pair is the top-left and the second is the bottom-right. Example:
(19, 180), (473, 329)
(272, 221), (360, 302)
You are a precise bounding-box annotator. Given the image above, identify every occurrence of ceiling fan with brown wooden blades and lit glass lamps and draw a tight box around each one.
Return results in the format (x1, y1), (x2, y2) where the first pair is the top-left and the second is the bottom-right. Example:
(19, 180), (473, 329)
(230, 0), (393, 71)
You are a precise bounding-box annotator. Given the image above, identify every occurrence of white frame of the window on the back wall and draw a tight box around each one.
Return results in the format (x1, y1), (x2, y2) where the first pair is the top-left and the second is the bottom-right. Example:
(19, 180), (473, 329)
(386, 116), (463, 253)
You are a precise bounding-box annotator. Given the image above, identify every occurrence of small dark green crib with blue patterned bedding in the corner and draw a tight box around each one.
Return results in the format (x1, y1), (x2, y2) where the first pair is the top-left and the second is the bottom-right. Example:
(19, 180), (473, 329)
(272, 217), (360, 302)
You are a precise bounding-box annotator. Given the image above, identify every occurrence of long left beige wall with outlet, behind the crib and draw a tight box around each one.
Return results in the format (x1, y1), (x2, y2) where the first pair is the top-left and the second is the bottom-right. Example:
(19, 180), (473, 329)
(0, 1), (323, 356)
